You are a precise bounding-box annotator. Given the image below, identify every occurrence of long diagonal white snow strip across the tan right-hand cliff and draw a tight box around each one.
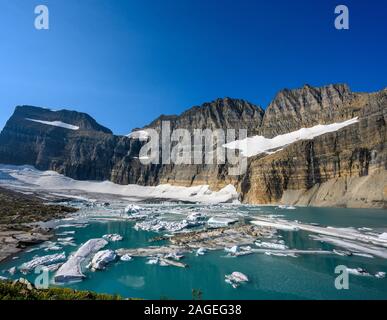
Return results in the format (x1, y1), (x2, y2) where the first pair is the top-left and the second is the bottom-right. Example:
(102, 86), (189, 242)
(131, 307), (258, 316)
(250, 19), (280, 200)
(223, 117), (359, 157)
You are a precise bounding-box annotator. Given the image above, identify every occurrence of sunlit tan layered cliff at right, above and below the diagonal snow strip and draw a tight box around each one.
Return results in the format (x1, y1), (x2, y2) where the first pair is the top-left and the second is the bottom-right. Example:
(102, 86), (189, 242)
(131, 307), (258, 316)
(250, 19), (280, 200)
(241, 86), (387, 207)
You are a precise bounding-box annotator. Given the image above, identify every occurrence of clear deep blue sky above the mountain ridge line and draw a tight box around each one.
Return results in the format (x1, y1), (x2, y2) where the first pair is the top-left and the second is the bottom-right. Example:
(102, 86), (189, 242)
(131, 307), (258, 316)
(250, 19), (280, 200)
(0, 0), (387, 134)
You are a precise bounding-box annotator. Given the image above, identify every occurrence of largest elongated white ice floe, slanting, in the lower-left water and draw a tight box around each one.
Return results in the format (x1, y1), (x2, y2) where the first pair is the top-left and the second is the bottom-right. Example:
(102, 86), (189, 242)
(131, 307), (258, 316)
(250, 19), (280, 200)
(55, 238), (108, 282)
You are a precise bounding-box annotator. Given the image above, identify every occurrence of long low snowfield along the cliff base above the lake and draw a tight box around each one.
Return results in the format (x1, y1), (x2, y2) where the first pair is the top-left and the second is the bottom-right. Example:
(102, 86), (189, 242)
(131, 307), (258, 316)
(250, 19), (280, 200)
(0, 164), (239, 204)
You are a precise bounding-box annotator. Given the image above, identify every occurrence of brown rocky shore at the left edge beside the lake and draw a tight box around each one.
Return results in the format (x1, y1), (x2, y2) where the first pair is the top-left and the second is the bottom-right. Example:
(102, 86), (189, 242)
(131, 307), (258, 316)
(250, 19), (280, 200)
(0, 187), (77, 262)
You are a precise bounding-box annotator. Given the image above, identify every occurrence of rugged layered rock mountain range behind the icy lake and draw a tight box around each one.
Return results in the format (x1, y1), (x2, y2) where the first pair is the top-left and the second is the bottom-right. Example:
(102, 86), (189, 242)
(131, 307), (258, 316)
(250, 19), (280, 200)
(0, 84), (387, 208)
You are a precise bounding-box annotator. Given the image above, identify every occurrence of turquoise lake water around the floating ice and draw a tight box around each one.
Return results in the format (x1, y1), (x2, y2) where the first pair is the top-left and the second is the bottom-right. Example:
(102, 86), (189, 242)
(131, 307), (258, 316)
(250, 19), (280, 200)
(0, 204), (387, 299)
